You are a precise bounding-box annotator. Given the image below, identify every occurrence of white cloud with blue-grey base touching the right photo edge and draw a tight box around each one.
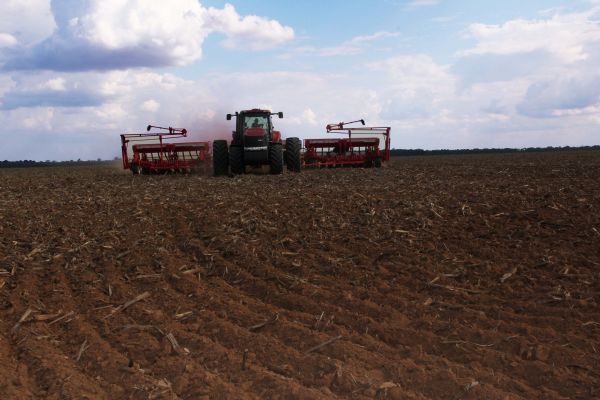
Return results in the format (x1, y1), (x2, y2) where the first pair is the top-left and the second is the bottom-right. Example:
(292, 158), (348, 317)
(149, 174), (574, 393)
(452, 6), (600, 119)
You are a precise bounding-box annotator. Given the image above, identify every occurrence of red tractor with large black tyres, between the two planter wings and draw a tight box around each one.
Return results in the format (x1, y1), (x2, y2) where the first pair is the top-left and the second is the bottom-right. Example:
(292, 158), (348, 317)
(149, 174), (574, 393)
(213, 108), (302, 176)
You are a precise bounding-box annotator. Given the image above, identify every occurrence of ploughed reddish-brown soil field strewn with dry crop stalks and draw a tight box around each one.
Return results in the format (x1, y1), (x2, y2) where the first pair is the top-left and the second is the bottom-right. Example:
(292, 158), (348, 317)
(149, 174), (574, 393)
(0, 152), (600, 400)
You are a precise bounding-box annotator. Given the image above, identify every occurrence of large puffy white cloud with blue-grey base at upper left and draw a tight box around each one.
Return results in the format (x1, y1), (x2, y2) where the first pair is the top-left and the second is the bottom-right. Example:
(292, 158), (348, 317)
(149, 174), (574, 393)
(0, 0), (294, 71)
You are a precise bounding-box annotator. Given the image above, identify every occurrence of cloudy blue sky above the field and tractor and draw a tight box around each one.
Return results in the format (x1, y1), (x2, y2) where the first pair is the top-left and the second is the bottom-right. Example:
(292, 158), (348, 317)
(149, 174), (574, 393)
(0, 0), (600, 160)
